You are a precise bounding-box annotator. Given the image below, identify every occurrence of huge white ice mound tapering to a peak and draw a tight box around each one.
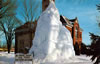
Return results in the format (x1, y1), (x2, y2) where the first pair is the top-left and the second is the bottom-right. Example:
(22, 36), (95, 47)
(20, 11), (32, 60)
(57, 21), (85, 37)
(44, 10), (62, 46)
(29, 2), (75, 63)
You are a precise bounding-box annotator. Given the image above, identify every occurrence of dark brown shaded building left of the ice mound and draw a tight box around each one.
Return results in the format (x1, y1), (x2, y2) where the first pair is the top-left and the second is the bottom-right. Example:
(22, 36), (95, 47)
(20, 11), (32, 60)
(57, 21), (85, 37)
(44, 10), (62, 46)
(15, 21), (37, 54)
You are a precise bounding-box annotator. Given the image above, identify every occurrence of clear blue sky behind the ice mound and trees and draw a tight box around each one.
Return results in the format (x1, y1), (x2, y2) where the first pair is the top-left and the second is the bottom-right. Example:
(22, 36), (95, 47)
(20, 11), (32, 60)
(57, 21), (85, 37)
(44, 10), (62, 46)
(2, 0), (100, 44)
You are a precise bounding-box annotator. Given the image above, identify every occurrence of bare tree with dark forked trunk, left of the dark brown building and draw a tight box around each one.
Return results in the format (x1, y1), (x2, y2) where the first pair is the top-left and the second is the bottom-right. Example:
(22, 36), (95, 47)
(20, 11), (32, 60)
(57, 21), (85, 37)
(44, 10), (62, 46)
(0, 16), (21, 53)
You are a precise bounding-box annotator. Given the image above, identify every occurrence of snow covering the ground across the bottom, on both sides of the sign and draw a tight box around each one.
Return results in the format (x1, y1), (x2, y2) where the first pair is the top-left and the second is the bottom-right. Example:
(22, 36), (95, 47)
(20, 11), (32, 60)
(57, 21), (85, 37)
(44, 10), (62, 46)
(0, 52), (93, 64)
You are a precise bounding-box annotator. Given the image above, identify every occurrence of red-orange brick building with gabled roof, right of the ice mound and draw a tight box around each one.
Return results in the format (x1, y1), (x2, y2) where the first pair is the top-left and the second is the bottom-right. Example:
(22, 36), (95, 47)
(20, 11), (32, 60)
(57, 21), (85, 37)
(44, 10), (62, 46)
(60, 15), (82, 55)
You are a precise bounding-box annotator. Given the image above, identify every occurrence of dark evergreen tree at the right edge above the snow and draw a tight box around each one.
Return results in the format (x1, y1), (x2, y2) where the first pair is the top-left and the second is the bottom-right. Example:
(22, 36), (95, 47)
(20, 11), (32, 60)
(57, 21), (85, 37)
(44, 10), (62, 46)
(90, 33), (100, 64)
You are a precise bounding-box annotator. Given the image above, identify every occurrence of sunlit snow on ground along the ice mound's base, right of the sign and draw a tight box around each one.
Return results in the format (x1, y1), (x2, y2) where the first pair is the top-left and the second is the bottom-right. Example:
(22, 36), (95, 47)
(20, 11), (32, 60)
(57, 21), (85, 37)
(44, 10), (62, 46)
(36, 55), (93, 64)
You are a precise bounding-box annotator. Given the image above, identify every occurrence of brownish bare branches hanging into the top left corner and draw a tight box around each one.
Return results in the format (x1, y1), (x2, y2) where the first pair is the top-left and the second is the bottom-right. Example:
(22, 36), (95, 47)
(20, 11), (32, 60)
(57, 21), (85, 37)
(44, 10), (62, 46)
(0, 0), (17, 18)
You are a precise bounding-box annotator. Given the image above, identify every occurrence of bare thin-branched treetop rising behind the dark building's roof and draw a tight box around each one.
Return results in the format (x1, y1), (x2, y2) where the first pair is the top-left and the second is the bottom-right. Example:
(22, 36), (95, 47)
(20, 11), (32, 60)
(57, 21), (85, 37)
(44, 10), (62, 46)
(21, 0), (40, 22)
